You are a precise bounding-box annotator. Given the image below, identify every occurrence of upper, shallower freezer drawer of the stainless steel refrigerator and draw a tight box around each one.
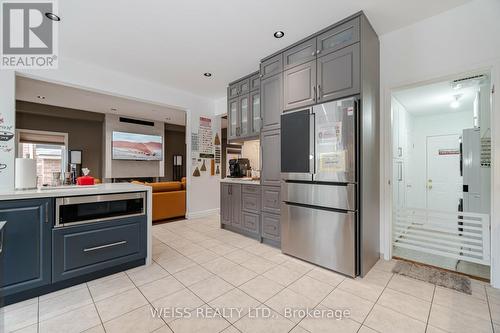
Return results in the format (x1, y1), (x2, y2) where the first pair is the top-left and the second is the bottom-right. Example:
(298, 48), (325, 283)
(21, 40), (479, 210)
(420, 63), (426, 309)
(282, 182), (356, 210)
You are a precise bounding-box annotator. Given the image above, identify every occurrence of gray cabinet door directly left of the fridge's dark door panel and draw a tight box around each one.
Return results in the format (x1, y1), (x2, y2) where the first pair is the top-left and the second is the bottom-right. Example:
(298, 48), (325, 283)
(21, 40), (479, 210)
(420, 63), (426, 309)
(260, 130), (281, 186)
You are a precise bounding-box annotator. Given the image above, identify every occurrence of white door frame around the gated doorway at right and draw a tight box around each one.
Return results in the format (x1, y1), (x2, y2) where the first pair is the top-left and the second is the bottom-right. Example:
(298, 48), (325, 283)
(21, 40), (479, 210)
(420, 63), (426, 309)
(380, 59), (500, 288)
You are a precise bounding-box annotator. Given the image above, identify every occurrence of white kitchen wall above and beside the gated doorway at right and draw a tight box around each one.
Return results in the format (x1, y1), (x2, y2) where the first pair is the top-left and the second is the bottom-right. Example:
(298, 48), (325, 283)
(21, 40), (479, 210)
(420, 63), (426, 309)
(380, 0), (500, 287)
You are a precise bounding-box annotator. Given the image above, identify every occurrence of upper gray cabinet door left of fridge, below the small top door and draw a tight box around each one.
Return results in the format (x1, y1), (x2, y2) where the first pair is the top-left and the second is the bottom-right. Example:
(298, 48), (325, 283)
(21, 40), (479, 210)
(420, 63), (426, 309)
(260, 73), (283, 131)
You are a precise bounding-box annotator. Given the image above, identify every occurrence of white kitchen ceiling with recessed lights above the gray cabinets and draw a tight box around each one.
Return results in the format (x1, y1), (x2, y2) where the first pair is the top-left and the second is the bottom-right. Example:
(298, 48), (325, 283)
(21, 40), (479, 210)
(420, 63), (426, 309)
(58, 0), (469, 98)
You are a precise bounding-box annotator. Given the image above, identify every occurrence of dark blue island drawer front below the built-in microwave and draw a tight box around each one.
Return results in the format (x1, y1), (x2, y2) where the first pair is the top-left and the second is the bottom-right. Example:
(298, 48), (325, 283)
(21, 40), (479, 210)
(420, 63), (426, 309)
(52, 217), (147, 282)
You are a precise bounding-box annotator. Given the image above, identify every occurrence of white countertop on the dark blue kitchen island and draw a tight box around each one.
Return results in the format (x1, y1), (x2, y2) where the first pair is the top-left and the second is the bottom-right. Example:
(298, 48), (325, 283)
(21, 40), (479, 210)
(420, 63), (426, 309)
(0, 183), (151, 200)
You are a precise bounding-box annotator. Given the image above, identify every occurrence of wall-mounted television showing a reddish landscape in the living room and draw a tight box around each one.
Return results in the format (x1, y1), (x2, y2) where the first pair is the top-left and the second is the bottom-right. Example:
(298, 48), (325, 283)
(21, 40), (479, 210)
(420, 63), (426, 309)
(112, 131), (163, 161)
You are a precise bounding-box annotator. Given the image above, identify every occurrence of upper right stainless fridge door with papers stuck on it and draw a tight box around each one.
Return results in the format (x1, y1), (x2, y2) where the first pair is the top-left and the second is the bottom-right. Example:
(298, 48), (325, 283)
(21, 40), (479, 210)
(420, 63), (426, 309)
(313, 98), (358, 183)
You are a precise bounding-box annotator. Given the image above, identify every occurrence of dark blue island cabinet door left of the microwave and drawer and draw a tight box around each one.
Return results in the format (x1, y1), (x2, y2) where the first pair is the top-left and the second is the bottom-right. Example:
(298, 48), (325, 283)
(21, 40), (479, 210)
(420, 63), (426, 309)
(0, 199), (54, 296)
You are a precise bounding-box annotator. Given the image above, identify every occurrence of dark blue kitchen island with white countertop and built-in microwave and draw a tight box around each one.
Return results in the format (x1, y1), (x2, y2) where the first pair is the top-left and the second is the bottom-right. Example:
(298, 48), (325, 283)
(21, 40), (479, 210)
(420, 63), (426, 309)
(0, 183), (152, 307)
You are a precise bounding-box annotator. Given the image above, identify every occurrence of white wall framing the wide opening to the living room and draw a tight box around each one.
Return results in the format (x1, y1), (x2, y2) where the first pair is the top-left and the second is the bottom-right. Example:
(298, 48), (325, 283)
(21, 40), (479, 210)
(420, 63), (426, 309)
(15, 57), (219, 216)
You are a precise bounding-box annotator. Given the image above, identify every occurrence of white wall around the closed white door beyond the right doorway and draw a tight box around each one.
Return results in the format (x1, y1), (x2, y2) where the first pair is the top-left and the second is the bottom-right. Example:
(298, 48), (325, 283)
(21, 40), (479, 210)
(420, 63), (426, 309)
(406, 110), (474, 208)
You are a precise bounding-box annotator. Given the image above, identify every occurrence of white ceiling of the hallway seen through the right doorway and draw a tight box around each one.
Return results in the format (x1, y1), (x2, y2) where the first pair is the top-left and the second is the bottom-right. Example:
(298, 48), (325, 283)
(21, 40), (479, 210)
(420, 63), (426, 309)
(394, 81), (478, 116)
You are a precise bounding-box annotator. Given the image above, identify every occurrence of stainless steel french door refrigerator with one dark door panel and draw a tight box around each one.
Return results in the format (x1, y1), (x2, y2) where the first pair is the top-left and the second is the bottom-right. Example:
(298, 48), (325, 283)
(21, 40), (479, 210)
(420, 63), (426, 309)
(281, 97), (360, 277)
